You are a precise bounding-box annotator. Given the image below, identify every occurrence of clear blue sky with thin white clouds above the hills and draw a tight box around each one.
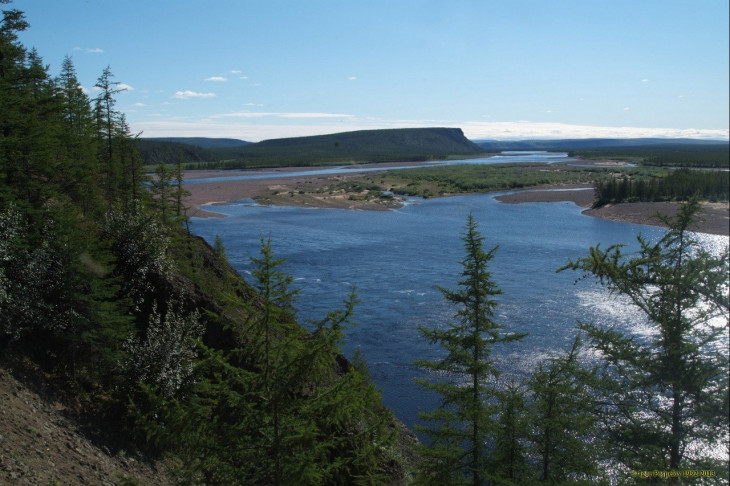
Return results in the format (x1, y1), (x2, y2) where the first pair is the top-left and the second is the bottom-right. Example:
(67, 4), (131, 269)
(11, 0), (730, 141)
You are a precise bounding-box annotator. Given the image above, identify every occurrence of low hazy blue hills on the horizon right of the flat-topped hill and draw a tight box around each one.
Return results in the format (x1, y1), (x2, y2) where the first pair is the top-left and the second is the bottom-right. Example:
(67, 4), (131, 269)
(474, 138), (728, 151)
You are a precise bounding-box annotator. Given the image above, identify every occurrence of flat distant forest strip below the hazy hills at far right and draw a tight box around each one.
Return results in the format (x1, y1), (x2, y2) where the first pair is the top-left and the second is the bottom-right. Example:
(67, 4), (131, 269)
(570, 143), (730, 169)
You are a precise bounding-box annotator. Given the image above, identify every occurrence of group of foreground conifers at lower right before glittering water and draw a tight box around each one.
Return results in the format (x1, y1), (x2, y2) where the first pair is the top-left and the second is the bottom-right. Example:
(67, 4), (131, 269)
(417, 211), (730, 485)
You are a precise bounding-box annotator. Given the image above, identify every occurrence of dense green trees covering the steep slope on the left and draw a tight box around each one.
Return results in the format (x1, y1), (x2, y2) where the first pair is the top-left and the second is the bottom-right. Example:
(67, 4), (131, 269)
(0, 5), (407, 485)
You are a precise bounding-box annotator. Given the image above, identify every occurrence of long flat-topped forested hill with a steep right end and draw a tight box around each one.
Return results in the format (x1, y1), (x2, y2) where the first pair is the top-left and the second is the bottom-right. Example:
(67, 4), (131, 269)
(210, 128), (484, 167)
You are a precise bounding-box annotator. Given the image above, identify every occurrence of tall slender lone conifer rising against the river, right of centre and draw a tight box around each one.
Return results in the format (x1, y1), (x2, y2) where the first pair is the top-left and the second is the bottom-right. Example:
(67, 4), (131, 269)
(417, 214), (524, 486)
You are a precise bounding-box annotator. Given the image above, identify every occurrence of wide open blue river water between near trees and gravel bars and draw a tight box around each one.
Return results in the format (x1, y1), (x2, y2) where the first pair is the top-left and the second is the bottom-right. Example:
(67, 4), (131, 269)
(186, 155), (728, 428)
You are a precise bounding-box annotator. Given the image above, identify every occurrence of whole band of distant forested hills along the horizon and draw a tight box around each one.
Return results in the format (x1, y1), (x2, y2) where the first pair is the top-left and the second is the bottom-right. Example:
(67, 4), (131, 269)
(138, 133), (728, 168)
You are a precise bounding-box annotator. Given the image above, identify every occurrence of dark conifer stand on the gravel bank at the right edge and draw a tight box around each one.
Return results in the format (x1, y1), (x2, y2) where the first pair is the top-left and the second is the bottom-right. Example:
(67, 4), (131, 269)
(595, 169), (730, 206)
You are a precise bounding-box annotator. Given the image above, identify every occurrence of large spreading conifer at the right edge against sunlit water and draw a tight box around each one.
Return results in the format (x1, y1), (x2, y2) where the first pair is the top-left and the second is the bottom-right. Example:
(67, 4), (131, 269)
(564, 199), (730, 471)
